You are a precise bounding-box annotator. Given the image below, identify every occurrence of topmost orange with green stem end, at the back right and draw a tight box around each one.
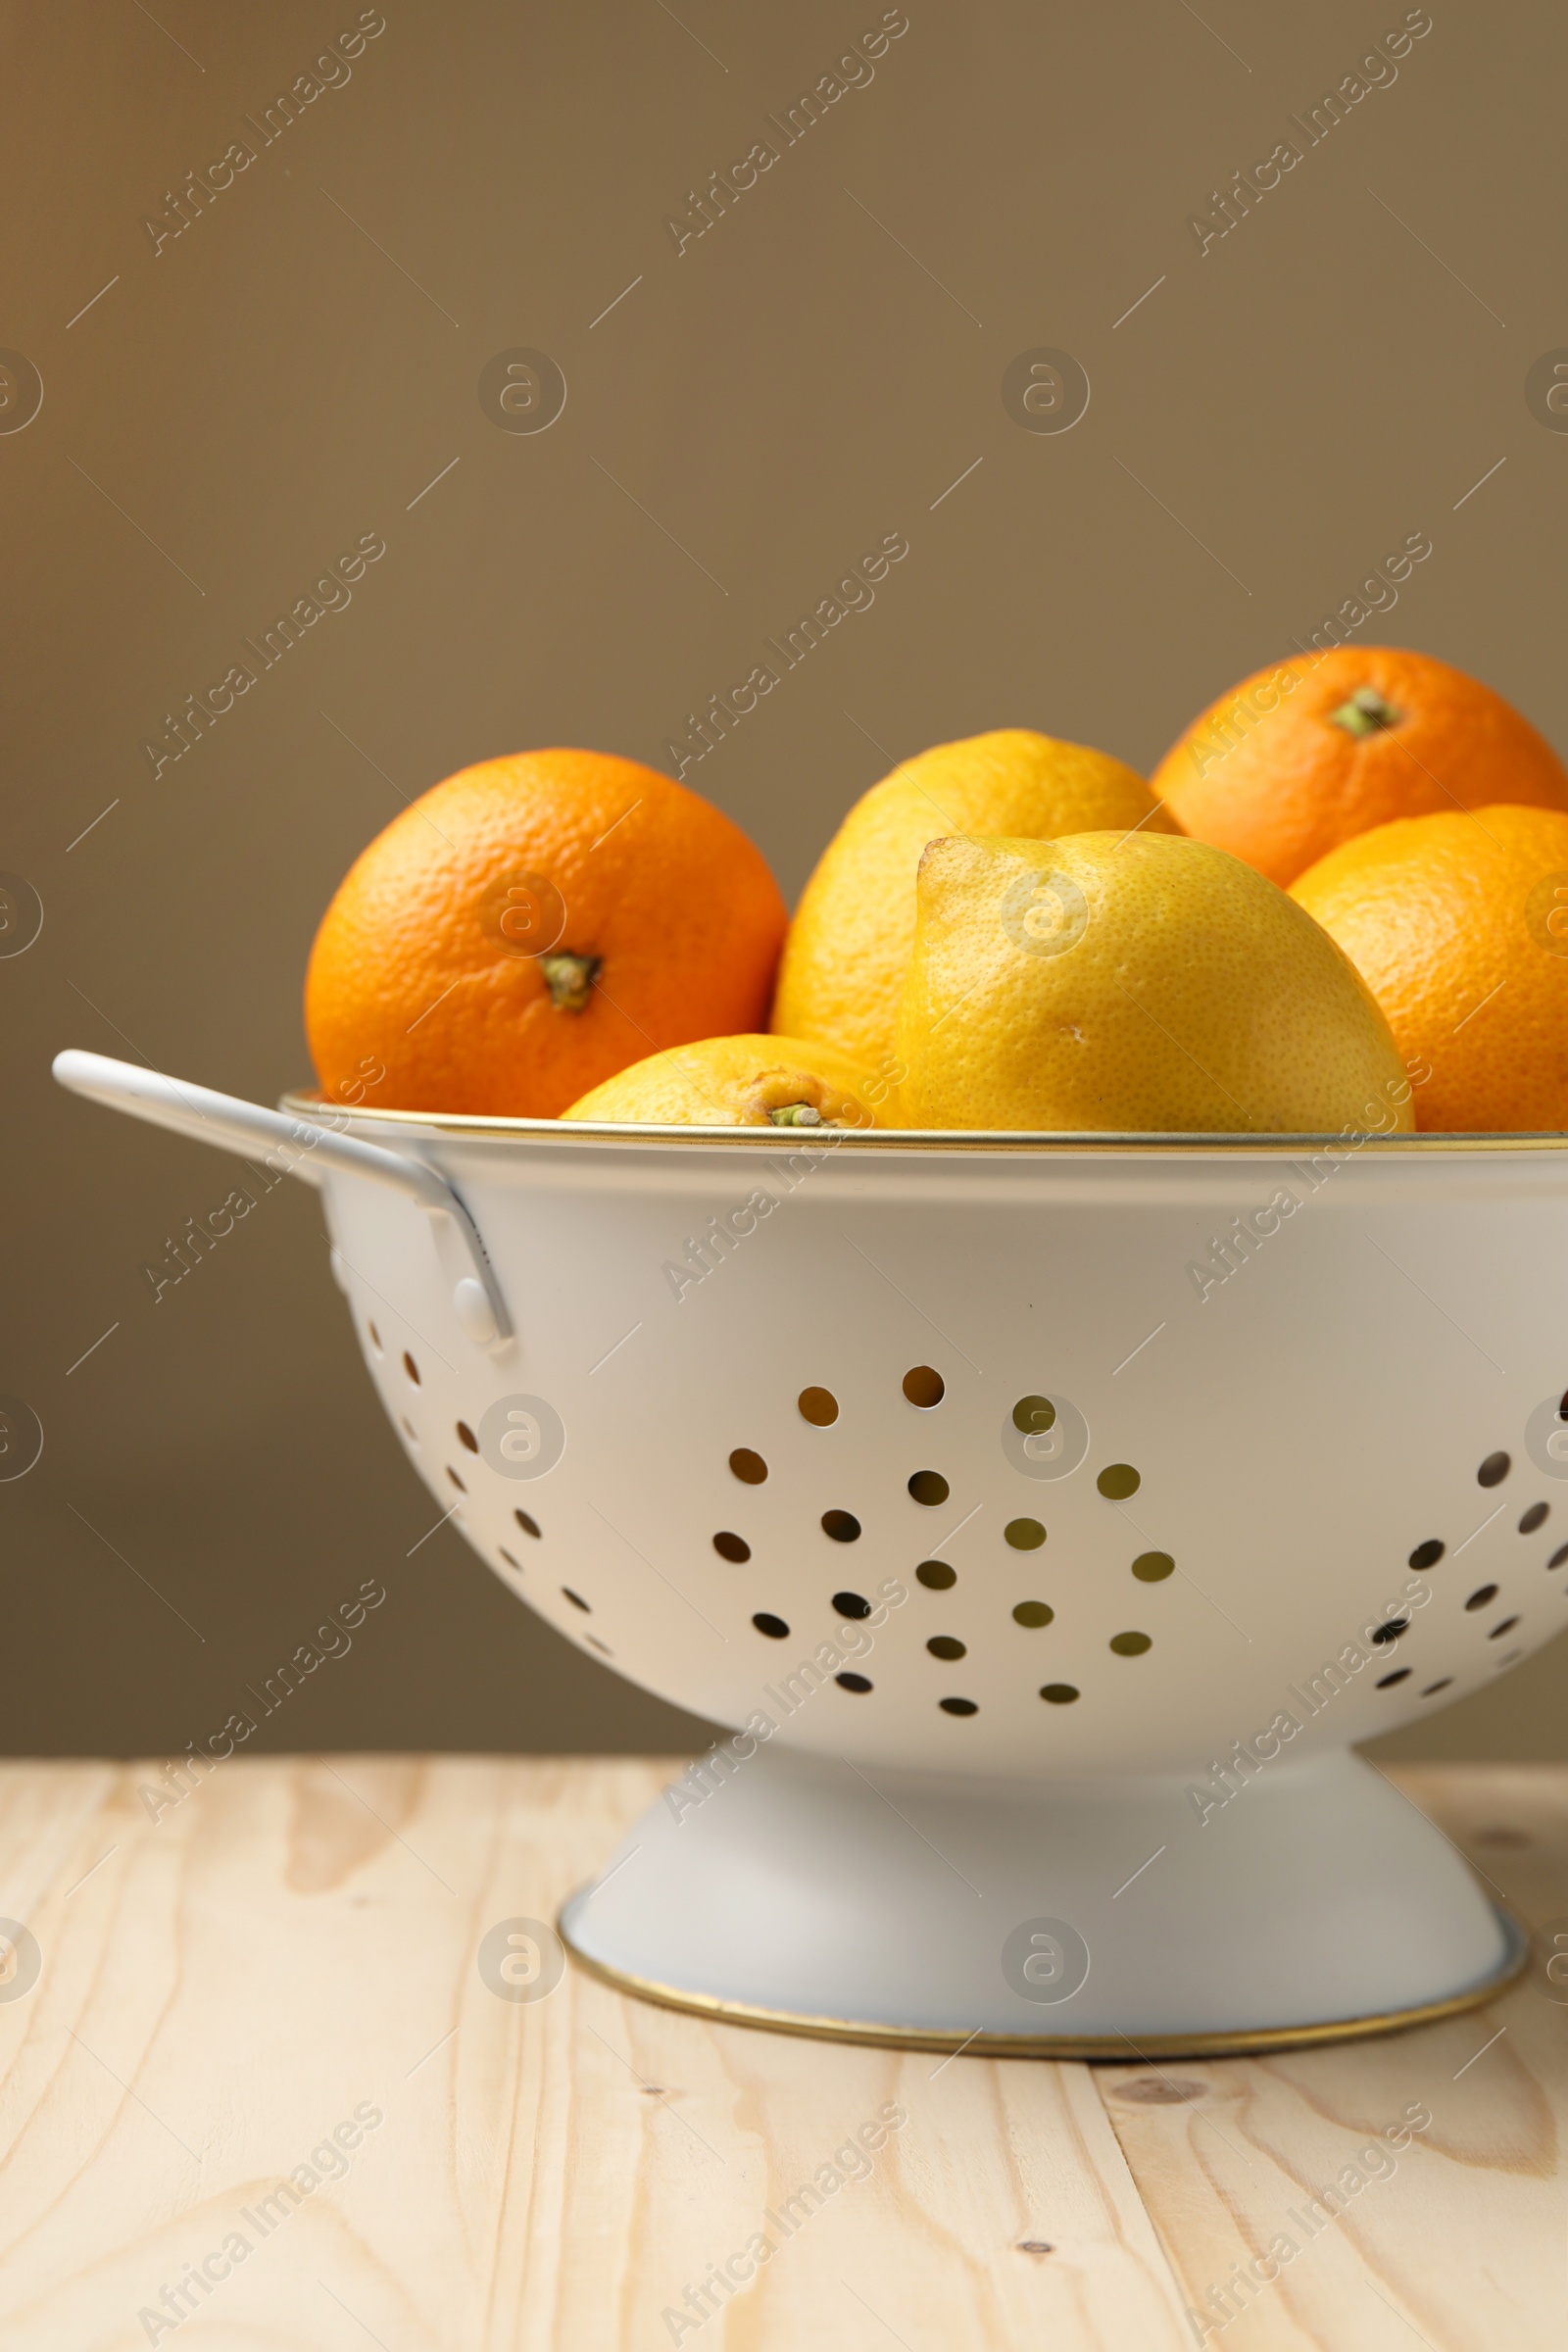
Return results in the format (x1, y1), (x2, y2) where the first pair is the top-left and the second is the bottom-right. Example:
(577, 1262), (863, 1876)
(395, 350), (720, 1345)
(1150, 645), (1568, 887)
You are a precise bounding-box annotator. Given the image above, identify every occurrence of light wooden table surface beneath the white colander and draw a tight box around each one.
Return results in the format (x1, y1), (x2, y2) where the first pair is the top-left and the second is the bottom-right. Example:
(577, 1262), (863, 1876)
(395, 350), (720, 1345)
(0, 1757), (1568, 2352)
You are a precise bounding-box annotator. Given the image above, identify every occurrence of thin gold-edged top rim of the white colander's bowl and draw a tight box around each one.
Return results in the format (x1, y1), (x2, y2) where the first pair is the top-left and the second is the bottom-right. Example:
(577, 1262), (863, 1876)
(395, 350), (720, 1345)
(279, 1089), (1568, 1157)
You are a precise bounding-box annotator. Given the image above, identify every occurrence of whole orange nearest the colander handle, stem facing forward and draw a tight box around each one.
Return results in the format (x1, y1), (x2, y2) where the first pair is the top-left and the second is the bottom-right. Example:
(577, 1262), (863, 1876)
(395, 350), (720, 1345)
(306, 751), (785, 1119)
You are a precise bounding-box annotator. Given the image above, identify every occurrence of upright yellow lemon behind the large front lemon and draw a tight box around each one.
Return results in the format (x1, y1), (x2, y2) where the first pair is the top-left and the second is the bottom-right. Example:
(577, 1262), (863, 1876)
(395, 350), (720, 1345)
(773, 727), (1175, 1072)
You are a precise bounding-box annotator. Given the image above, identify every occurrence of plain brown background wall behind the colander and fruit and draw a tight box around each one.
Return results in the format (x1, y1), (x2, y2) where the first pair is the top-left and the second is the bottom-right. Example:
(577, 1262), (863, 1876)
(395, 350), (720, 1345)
(0, 0), (1568, 1754)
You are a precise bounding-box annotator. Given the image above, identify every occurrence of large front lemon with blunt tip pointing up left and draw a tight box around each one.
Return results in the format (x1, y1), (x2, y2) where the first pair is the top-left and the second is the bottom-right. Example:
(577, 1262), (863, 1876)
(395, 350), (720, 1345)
(898, 833), (1413, 1134)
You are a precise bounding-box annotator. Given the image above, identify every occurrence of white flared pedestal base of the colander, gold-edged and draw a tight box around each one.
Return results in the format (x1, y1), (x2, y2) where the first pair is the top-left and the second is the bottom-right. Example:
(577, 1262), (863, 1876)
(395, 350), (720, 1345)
(562, 1747), (1521, 2058)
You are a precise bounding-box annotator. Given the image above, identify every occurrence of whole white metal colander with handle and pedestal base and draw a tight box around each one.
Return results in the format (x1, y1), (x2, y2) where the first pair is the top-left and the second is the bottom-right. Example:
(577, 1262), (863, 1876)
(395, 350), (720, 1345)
(54, 1054), (1568, 2056)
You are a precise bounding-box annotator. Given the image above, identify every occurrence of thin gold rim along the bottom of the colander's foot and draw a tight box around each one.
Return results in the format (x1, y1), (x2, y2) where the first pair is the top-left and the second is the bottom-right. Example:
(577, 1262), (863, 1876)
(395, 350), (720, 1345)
(555, 1898), (1531, 2065)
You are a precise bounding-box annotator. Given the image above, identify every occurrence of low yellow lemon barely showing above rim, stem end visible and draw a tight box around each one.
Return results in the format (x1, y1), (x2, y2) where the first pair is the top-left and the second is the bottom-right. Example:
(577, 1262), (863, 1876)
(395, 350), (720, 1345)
(562, 1035), (894, 1129)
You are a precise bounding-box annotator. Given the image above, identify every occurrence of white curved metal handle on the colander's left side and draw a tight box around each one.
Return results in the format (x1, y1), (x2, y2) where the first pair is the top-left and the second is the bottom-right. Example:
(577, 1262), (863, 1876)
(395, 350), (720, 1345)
(54, 1049), (513, 1348)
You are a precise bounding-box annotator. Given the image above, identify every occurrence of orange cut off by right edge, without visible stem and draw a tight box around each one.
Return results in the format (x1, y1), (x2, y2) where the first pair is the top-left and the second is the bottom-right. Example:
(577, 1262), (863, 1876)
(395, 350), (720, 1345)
(1291, 807), (1568, 1134)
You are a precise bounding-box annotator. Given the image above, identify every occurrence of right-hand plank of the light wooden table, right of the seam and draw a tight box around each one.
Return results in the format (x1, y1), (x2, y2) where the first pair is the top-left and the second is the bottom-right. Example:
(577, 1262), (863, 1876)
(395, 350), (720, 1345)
(1096, 1766), (1568, 2352)
